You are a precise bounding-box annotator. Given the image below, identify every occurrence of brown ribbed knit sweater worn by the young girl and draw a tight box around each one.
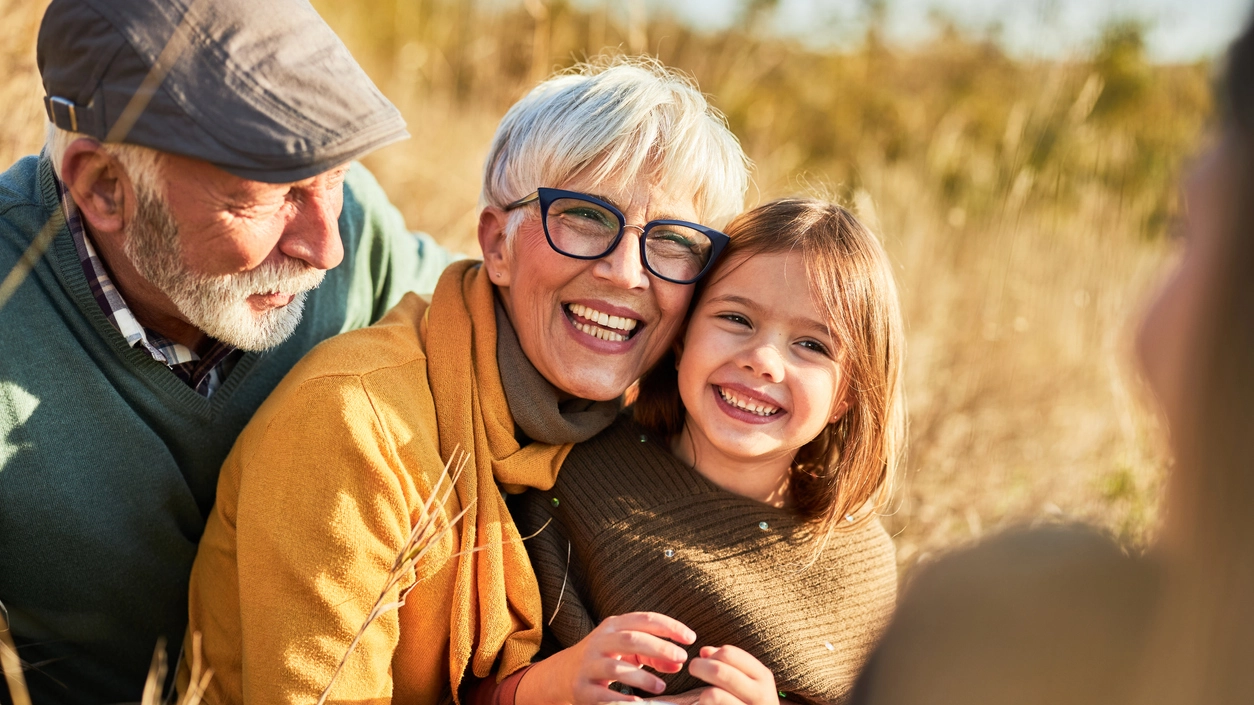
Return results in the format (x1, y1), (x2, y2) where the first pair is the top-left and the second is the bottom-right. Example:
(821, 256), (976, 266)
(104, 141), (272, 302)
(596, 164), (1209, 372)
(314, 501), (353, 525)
(513, 416), (897, 702)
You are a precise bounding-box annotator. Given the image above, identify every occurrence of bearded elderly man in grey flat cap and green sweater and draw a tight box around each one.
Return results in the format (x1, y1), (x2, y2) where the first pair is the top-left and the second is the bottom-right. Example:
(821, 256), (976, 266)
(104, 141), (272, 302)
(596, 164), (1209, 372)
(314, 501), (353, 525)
(0, 0), (450, 704)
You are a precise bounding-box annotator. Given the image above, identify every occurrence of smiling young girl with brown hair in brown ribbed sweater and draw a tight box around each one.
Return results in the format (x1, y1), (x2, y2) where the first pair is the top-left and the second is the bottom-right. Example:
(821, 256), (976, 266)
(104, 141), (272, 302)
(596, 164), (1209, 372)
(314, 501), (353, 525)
(515, 198), (904, 704)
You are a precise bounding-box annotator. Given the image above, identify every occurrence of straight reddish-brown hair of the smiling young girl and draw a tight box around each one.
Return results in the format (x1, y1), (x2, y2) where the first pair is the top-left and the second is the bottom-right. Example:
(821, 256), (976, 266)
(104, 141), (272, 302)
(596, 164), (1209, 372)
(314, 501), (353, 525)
(633, 198), (905, 556)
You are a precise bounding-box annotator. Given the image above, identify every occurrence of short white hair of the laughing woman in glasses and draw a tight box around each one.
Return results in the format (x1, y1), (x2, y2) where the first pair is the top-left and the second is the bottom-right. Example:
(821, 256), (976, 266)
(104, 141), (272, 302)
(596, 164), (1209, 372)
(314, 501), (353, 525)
(483, 58), (749, 227)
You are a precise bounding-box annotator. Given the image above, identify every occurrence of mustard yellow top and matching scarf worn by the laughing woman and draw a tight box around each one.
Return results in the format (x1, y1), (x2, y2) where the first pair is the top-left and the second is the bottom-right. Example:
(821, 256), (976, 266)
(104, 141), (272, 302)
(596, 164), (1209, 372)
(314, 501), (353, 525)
(179, 262), (571, 705)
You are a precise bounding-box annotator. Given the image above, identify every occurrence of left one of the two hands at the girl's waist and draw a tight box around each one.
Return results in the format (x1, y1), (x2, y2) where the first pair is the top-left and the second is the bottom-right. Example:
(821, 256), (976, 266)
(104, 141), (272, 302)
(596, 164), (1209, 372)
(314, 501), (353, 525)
(514, 612), (696, 705)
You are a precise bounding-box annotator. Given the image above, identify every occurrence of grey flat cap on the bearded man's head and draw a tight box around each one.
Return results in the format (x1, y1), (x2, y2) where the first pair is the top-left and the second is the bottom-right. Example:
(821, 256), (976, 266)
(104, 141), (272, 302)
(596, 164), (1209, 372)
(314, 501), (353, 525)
(38, 0), (409, 183)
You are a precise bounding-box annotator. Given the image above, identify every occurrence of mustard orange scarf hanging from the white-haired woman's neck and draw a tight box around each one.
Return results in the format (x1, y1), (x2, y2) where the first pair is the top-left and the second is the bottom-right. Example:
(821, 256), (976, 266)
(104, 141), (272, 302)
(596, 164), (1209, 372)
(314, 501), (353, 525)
(423, 261), (573, 692)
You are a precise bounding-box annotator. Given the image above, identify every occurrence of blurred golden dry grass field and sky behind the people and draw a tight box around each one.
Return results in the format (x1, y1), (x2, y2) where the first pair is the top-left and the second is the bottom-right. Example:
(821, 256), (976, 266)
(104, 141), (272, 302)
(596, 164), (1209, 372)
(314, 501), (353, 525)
(0, 0), (1246, 568)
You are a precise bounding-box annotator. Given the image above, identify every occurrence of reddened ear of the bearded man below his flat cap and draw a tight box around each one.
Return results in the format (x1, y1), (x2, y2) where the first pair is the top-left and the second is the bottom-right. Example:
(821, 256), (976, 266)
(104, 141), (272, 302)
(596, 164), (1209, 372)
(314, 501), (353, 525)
(61, 138), (132, 235)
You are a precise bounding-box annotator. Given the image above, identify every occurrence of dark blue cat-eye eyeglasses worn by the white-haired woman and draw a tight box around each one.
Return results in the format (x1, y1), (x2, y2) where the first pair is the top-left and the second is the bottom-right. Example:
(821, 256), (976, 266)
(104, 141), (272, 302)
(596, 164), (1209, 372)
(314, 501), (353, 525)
(505, 188), (729, 284)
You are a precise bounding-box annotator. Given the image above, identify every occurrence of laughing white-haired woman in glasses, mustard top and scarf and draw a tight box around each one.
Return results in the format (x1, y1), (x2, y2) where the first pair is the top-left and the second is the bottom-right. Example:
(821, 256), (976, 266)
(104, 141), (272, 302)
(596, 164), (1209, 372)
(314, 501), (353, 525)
(182, 61), (747, 704)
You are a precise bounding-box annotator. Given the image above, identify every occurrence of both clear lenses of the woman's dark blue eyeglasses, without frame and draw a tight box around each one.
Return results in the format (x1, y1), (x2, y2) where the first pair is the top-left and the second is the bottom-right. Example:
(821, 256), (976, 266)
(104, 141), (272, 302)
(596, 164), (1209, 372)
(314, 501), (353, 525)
(544, 198), (712, 281)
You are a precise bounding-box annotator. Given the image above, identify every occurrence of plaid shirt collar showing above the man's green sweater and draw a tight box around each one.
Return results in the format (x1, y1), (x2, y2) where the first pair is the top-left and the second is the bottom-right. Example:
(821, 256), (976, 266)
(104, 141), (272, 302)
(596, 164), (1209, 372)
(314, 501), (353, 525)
(53, 177), (242, 398)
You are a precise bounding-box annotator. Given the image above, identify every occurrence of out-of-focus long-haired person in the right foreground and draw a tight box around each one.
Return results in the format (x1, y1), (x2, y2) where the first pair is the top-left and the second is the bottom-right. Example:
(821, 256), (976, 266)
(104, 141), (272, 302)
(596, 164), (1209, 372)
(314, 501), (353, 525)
(854, 10), (1254, 705)
